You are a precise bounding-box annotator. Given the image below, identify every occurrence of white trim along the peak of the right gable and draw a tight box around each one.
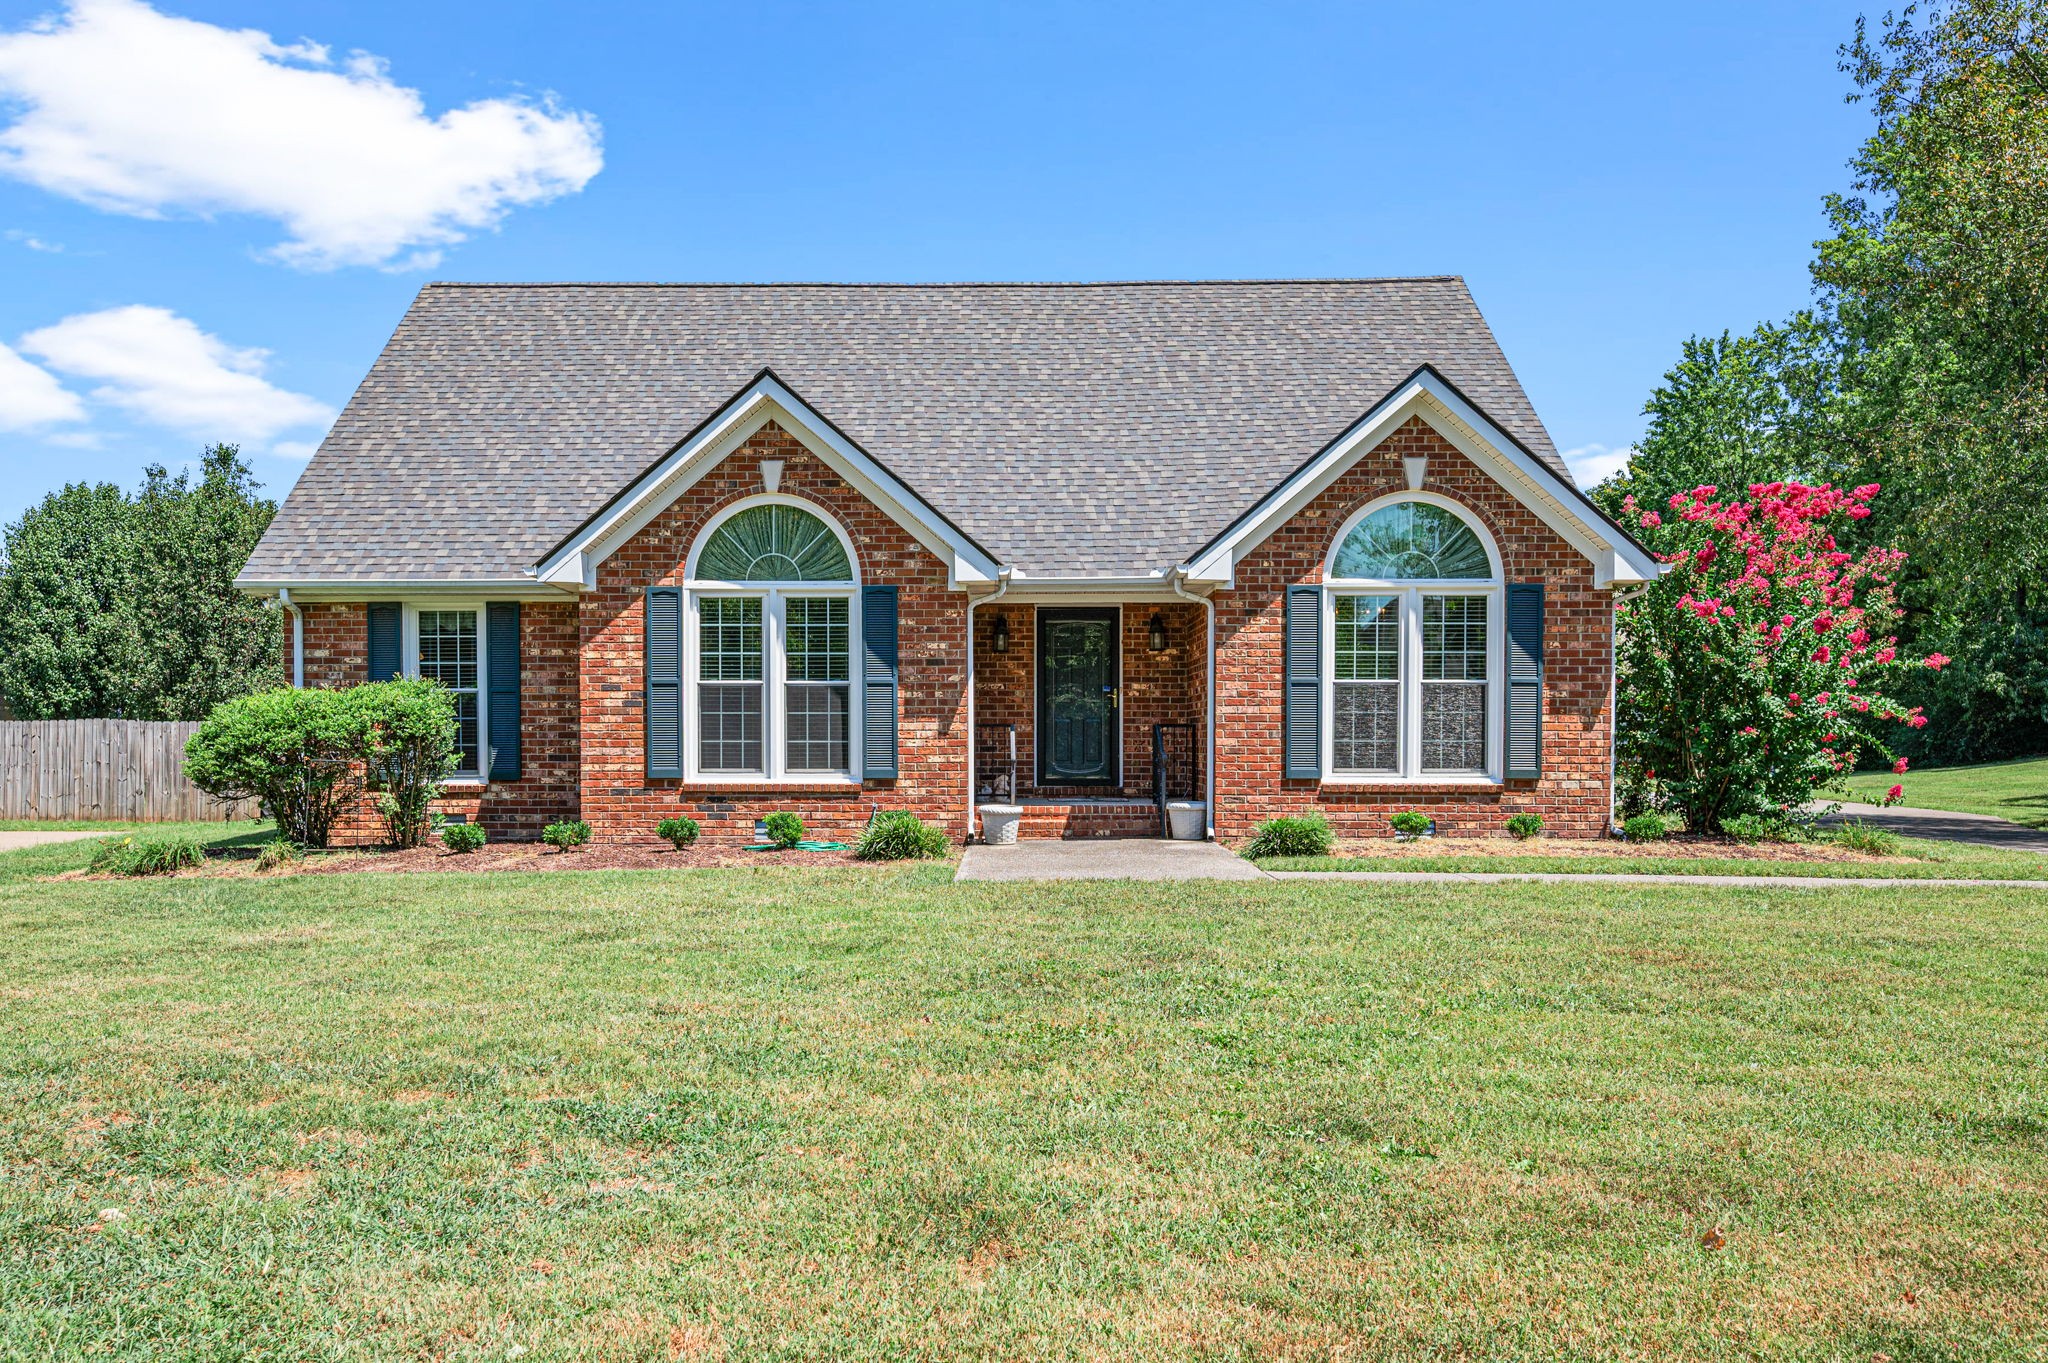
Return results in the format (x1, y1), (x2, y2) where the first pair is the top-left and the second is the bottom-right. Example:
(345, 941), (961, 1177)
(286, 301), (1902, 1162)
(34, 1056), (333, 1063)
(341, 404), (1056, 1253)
(1186, 370), (1663, 587)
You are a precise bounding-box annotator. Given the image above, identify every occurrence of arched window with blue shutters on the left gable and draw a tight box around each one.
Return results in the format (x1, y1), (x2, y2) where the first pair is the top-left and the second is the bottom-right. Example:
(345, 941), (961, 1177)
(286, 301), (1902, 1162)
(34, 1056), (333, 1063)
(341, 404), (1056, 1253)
(684, 497), (860, 782)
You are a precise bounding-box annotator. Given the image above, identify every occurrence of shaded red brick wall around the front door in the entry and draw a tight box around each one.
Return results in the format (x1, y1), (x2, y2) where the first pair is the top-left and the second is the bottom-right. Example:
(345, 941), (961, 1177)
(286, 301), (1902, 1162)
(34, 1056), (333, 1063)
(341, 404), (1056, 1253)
(975, 602), (1208, 798)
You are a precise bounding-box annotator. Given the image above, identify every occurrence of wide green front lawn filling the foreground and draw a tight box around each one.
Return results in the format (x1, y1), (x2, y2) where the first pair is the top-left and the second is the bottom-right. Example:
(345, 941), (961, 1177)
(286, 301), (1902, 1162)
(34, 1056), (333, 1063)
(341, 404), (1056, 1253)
(0, 845), (2048, 1363)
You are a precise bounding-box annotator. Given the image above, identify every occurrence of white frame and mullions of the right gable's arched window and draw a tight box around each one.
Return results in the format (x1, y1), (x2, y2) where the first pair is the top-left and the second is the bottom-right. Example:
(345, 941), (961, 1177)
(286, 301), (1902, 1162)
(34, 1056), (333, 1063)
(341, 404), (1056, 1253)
(1321, 491), (1507, 786)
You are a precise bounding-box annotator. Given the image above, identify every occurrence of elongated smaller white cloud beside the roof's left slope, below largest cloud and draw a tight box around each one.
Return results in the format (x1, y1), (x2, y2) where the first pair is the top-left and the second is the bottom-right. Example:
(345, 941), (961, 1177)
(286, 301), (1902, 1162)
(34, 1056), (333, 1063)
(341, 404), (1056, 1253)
(20, 305), (334, 444)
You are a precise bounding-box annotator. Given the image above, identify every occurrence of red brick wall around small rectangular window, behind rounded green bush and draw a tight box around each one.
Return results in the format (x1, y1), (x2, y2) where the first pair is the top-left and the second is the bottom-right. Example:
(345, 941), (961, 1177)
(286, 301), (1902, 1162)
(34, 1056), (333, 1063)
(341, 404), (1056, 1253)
(285, 602), (580, 847)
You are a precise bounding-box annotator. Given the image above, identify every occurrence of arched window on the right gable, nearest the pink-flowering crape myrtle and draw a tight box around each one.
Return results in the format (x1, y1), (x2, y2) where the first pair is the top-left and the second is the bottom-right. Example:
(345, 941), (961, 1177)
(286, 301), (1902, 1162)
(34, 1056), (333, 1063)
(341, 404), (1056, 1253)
(1323, 493), (1501, 780)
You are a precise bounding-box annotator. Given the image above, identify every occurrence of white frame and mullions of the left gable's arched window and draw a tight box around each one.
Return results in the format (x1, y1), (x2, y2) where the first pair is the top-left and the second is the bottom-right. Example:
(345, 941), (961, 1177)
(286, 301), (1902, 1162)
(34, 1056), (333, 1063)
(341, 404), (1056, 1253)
(682, 493), (864, 786)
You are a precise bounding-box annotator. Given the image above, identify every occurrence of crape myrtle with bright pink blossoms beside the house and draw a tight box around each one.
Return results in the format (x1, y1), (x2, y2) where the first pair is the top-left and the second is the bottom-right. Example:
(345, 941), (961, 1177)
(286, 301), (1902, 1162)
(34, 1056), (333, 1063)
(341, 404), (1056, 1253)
(1616, 483), (1948, 833)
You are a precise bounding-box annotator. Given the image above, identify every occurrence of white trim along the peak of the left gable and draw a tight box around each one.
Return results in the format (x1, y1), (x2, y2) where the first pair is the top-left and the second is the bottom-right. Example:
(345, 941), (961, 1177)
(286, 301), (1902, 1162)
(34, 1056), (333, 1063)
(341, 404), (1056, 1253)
(535, 372), (997, 589)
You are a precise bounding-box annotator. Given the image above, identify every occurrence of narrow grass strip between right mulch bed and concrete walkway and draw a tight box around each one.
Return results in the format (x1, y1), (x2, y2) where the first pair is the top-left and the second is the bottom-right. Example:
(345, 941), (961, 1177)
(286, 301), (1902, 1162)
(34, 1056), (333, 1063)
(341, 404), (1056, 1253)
(1260, 837), (2048, 880)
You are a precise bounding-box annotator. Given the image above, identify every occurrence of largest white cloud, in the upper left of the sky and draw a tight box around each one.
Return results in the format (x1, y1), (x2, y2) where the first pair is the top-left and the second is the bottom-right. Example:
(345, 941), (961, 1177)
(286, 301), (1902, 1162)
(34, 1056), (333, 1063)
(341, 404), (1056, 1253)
(0, 0), (604, 268)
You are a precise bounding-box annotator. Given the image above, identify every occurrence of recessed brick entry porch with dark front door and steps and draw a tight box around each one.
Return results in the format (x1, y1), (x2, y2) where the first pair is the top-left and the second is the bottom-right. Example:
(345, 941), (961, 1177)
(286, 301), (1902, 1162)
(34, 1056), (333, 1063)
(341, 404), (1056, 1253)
(975, 600), (1208, 839)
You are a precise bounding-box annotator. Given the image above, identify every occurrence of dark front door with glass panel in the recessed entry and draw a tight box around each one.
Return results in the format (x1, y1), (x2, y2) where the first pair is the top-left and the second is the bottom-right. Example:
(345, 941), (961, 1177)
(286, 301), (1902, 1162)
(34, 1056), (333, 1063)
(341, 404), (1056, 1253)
(1038, 606), (1122, 786)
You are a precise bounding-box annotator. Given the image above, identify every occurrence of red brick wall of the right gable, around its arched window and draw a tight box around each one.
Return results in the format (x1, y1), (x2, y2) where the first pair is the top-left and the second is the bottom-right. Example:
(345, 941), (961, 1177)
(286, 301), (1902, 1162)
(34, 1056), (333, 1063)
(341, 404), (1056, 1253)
(1214, 417), (1612, 839)
